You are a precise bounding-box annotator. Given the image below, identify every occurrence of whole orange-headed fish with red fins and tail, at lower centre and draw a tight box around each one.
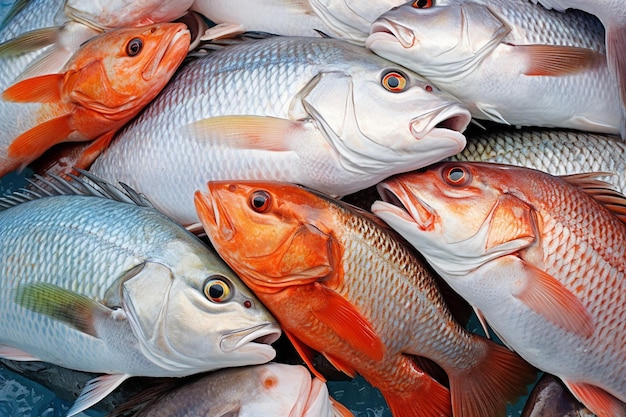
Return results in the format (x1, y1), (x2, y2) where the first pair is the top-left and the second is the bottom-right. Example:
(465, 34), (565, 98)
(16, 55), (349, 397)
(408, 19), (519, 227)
(195, 180), (535, 417)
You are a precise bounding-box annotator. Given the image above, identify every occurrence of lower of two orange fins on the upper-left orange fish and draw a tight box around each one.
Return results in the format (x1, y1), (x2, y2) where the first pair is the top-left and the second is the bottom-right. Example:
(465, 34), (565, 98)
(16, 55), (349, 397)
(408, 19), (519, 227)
(7, 114), (72, 161)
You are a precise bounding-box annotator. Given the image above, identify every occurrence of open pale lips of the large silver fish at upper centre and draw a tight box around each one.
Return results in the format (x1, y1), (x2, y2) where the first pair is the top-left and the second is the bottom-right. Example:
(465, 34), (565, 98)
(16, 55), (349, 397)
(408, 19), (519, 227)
(410, 103), (472, 153)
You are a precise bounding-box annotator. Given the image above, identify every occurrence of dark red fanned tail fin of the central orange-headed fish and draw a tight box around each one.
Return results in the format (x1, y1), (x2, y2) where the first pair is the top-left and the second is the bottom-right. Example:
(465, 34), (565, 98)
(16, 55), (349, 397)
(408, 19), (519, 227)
(448, 336), (537, 417)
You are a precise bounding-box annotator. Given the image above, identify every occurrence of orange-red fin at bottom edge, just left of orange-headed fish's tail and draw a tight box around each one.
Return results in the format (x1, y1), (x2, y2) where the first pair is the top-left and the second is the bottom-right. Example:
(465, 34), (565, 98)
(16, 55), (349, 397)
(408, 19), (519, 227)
(381, 375), (452, 417)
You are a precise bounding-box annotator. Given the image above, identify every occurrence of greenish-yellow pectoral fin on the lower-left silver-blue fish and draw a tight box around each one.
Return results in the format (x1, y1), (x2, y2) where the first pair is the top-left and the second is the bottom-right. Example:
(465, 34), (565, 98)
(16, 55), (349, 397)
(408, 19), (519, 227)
(15, 282), (124, 337)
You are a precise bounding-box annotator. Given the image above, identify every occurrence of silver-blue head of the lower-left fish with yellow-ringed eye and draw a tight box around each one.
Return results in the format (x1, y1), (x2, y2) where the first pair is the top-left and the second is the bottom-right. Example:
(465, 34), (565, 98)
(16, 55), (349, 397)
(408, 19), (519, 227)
(122, 241), (281, 376)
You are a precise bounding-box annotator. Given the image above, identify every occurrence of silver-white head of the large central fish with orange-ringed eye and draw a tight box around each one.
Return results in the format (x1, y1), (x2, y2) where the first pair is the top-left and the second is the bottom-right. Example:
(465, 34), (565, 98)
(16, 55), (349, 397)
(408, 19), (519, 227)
(297, 52), (471, 180)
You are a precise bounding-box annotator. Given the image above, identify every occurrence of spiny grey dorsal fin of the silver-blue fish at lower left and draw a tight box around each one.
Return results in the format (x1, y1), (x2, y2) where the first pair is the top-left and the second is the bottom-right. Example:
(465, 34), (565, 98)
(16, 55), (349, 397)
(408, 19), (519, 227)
(0, 168), (154, 211)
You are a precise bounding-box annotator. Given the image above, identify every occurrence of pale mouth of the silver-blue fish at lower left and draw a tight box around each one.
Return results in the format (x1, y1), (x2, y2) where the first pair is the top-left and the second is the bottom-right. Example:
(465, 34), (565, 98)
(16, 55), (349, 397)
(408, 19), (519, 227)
(220, 322), (281, 361)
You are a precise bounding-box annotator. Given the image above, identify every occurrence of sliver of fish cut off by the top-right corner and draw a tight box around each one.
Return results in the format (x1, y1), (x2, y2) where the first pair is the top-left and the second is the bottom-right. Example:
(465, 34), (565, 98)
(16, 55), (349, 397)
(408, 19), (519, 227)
(532, 0), (626, 139)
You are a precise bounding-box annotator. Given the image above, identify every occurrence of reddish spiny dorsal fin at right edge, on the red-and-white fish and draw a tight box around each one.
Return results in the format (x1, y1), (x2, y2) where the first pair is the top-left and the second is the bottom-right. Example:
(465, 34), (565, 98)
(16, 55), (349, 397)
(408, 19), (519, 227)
(560, 172), (626, 223)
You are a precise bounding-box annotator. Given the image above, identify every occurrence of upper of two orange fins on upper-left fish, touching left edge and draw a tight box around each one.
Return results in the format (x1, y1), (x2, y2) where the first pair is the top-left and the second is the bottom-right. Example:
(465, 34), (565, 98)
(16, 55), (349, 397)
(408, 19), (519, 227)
(2, 74), (64, 103)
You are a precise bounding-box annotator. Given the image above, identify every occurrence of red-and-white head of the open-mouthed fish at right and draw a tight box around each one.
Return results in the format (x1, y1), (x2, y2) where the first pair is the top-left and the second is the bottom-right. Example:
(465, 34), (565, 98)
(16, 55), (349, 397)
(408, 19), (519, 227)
(372, 162), (536, 277)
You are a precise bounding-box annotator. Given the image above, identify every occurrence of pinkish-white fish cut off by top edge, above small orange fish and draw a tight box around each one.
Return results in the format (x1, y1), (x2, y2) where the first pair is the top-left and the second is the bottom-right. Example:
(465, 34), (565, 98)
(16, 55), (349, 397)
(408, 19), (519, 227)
(65, 0), (193, 30)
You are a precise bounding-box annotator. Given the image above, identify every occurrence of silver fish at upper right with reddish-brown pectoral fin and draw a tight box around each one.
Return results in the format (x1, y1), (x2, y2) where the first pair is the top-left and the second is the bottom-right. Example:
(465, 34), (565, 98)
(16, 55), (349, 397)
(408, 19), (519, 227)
(366, 0), (621, 134)
